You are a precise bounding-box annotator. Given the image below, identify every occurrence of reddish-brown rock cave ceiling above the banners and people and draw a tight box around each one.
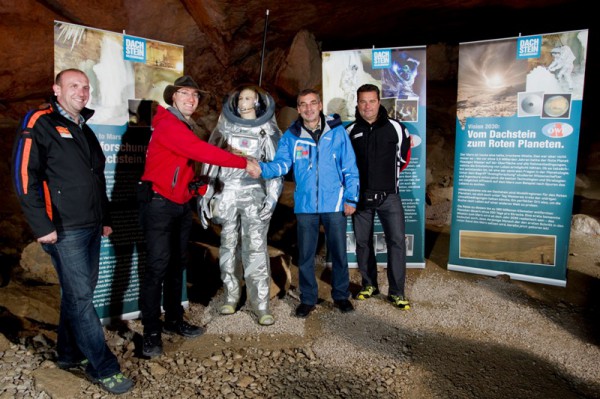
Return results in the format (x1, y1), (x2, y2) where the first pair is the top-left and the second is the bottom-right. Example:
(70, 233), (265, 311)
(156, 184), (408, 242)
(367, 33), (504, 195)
(0, 0), (596, 120)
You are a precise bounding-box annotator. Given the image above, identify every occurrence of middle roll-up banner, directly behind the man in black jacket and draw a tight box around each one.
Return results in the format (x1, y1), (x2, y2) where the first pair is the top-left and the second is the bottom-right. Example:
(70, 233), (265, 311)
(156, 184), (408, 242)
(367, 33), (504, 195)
(322, 46), (427, 268)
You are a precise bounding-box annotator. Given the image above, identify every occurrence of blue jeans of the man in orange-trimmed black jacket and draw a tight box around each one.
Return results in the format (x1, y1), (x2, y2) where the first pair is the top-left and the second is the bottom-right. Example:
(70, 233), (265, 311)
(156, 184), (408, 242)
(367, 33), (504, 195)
(42, 226), (120, 378)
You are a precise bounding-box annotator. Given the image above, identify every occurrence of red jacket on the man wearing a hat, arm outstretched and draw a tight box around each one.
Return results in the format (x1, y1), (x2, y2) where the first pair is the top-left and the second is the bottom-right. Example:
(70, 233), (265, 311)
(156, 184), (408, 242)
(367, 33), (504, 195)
(142, 106), (246, 204)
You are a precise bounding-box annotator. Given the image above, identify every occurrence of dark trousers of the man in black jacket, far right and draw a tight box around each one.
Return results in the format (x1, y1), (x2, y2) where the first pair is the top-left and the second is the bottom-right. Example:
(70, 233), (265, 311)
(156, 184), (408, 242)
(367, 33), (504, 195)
(352, 194), (406, 296)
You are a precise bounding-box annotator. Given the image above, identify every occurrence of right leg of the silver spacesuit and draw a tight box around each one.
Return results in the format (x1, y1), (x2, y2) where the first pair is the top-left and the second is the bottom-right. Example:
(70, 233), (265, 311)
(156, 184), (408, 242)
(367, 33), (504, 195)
(238, 189), (271, 318)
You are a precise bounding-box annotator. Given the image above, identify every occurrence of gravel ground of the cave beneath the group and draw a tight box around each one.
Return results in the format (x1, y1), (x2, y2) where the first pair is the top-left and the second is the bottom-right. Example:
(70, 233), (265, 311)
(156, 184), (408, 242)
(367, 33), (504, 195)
(0, 230), (600, 399)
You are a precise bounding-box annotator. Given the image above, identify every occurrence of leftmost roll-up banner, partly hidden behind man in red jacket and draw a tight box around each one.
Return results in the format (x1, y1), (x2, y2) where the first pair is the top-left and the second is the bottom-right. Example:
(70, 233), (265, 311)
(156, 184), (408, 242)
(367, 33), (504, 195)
(54, 21), (187, 321)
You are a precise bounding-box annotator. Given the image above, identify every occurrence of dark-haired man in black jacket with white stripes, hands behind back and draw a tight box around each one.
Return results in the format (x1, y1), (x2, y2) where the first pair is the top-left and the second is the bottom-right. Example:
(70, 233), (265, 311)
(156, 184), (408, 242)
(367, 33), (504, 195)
(346, 84), (410, 310)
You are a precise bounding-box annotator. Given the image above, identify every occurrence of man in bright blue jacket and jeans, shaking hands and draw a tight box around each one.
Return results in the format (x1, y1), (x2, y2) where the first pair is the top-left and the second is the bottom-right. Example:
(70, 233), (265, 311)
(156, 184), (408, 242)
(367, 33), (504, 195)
(247, 89), (359, 318)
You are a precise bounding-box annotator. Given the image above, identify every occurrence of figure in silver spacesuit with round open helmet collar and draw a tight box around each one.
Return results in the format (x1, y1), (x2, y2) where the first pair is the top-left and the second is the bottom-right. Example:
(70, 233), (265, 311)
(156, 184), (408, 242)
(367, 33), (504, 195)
(199, 86), (283, 325)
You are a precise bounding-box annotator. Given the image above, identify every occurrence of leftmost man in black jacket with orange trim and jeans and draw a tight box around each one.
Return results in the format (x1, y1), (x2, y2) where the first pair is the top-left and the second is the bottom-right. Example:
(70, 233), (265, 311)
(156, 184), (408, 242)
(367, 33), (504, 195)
(12, 69), (133, 394)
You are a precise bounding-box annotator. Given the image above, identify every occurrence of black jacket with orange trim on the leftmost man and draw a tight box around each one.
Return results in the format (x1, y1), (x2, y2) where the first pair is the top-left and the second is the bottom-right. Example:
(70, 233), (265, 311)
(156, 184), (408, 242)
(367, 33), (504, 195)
(12, 97), (111, 238)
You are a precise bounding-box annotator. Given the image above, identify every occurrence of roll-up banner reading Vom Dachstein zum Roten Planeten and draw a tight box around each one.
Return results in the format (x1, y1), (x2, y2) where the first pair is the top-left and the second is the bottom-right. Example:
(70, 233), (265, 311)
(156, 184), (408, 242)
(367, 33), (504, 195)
(448, 30), (588, 286)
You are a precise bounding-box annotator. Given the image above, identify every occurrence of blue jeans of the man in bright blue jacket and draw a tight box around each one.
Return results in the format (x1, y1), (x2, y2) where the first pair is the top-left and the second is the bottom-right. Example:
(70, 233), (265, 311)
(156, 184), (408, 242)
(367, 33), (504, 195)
(296, 212), (350, 305)
